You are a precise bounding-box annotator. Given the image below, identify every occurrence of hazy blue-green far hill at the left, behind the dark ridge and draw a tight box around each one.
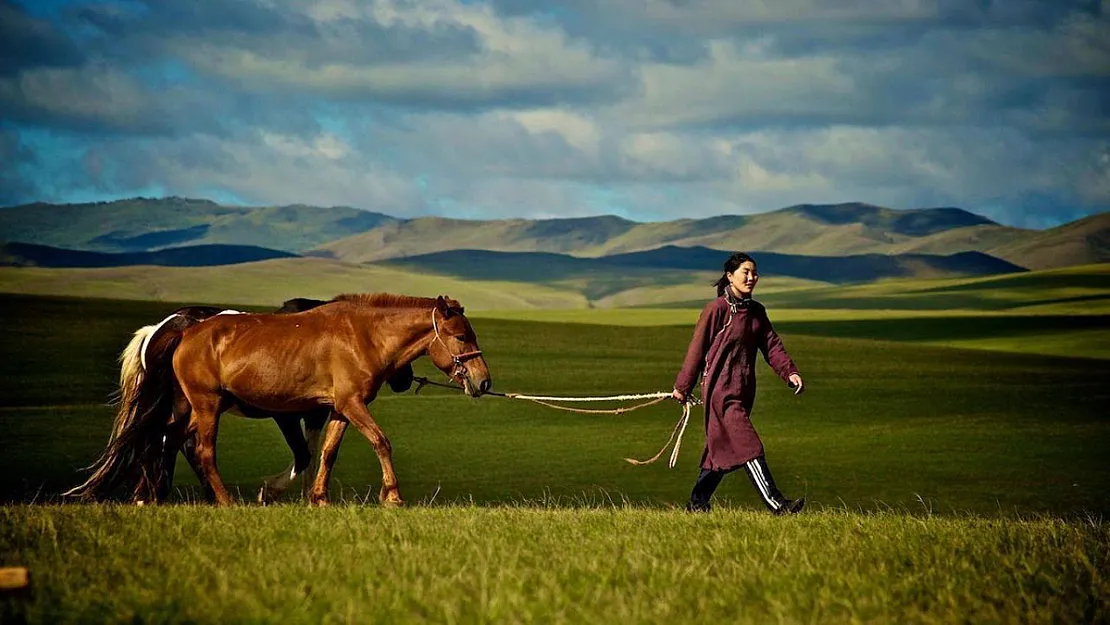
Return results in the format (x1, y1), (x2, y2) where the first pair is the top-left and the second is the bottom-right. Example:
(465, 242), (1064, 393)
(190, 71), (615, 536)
(0, 198), (395, 252)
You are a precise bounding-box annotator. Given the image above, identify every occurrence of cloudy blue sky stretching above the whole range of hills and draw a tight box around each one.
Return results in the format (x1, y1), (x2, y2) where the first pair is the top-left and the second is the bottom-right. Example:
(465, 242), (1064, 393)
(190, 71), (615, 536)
(0, 0), (1110, 228)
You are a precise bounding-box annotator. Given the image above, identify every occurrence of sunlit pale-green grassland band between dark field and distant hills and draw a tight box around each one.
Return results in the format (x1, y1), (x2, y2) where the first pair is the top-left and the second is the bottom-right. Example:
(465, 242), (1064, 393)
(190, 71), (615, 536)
(0, 257), (1110, 316)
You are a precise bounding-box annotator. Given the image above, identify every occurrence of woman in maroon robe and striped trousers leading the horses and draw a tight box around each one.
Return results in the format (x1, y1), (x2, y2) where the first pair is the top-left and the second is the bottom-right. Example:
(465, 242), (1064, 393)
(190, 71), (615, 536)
(673, 253), (806, 514)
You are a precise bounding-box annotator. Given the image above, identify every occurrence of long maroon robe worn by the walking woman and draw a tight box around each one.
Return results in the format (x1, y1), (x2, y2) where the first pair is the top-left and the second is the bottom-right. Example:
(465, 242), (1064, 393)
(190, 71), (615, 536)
(675, 294), (798, 471)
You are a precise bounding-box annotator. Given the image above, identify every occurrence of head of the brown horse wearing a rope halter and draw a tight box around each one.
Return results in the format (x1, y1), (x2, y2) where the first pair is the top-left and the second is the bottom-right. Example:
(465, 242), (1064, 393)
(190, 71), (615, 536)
(427, 295), (493, 397)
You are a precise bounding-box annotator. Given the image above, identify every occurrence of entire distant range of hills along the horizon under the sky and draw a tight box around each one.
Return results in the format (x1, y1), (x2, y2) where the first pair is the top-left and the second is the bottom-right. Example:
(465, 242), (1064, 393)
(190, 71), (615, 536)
(0, 198), (1110, 274)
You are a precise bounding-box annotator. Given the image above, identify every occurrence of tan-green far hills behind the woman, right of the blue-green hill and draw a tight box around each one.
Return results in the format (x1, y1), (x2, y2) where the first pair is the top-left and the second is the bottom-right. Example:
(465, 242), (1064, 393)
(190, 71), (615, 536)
(320, 204), (1027, 262)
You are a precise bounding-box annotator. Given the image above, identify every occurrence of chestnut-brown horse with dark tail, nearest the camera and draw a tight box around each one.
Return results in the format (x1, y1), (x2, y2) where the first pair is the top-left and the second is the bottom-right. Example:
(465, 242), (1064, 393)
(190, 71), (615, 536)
(66, 294), (491, 505)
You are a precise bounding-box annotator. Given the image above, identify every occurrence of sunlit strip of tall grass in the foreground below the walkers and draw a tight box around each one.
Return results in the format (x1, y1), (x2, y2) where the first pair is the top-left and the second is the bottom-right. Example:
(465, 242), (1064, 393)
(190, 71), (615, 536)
(0, 505), (1110, 624)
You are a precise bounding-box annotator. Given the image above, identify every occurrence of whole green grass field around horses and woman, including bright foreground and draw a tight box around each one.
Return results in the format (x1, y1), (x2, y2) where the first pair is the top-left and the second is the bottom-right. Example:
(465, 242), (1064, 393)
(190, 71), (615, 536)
(0, 295), (1110, 623)
